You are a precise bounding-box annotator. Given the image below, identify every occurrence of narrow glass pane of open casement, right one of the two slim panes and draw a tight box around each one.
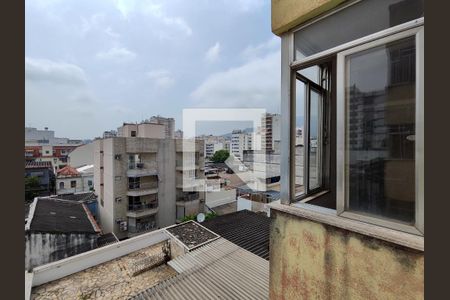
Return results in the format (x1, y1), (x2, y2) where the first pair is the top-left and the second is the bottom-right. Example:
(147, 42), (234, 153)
(309, 90), (322, 190)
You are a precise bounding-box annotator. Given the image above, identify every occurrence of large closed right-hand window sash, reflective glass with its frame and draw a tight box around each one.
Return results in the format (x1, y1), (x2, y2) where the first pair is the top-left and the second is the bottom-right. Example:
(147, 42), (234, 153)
(338, 27), (423, 233)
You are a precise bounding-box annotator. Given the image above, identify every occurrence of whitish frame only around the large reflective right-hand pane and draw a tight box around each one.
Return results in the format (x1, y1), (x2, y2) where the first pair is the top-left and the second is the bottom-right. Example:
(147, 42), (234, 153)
(336, 26), (424, 235)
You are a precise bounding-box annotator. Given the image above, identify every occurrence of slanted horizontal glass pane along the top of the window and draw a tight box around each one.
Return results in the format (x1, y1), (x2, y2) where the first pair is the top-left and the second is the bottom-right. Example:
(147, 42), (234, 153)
(294, 0), (424, 59)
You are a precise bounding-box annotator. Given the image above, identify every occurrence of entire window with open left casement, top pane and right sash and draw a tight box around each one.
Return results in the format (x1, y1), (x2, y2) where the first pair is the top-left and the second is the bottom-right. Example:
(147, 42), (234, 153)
(281, 0), (424, 235)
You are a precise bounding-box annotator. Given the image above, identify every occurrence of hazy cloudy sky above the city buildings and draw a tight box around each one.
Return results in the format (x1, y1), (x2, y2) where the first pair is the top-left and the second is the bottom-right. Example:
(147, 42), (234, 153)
(25, 0), (281, 139)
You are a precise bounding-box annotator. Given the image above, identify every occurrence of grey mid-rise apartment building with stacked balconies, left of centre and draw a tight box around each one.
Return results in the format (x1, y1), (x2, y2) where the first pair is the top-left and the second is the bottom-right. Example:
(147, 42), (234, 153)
(94, 135), (204, 239)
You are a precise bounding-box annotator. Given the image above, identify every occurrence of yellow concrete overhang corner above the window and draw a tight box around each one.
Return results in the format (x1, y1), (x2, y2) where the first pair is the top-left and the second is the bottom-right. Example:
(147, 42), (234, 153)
(272, 0), (346, 35)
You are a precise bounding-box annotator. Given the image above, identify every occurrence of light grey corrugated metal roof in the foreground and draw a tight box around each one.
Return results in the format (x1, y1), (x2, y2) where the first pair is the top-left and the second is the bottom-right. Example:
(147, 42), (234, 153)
(133, 238), (269, 300)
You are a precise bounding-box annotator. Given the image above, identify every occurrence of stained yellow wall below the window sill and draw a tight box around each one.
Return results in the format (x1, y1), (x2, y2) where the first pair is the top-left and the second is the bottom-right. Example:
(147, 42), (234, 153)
(270, 209), (424, 299)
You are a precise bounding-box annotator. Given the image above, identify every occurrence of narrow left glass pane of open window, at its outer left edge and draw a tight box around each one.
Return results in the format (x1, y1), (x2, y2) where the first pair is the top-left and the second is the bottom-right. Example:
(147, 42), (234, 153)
(295, 79), (305, 196)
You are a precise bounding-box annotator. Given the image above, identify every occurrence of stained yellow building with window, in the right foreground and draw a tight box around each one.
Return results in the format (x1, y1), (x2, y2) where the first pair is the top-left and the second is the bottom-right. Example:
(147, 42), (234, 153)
(269, 0), (424, 299)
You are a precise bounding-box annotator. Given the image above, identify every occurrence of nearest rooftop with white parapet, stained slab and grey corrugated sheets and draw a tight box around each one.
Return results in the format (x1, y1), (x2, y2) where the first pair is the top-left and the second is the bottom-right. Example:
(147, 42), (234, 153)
(25, 221), (269, 299)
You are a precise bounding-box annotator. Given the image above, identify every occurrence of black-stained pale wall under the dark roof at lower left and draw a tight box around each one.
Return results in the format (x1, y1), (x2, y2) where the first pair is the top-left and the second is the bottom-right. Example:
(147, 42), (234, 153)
(25, 232), (98, 270)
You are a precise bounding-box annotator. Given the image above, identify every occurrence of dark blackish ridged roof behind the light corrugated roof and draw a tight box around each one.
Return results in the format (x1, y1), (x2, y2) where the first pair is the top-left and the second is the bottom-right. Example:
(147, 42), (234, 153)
(202, 210), (270, 260)
